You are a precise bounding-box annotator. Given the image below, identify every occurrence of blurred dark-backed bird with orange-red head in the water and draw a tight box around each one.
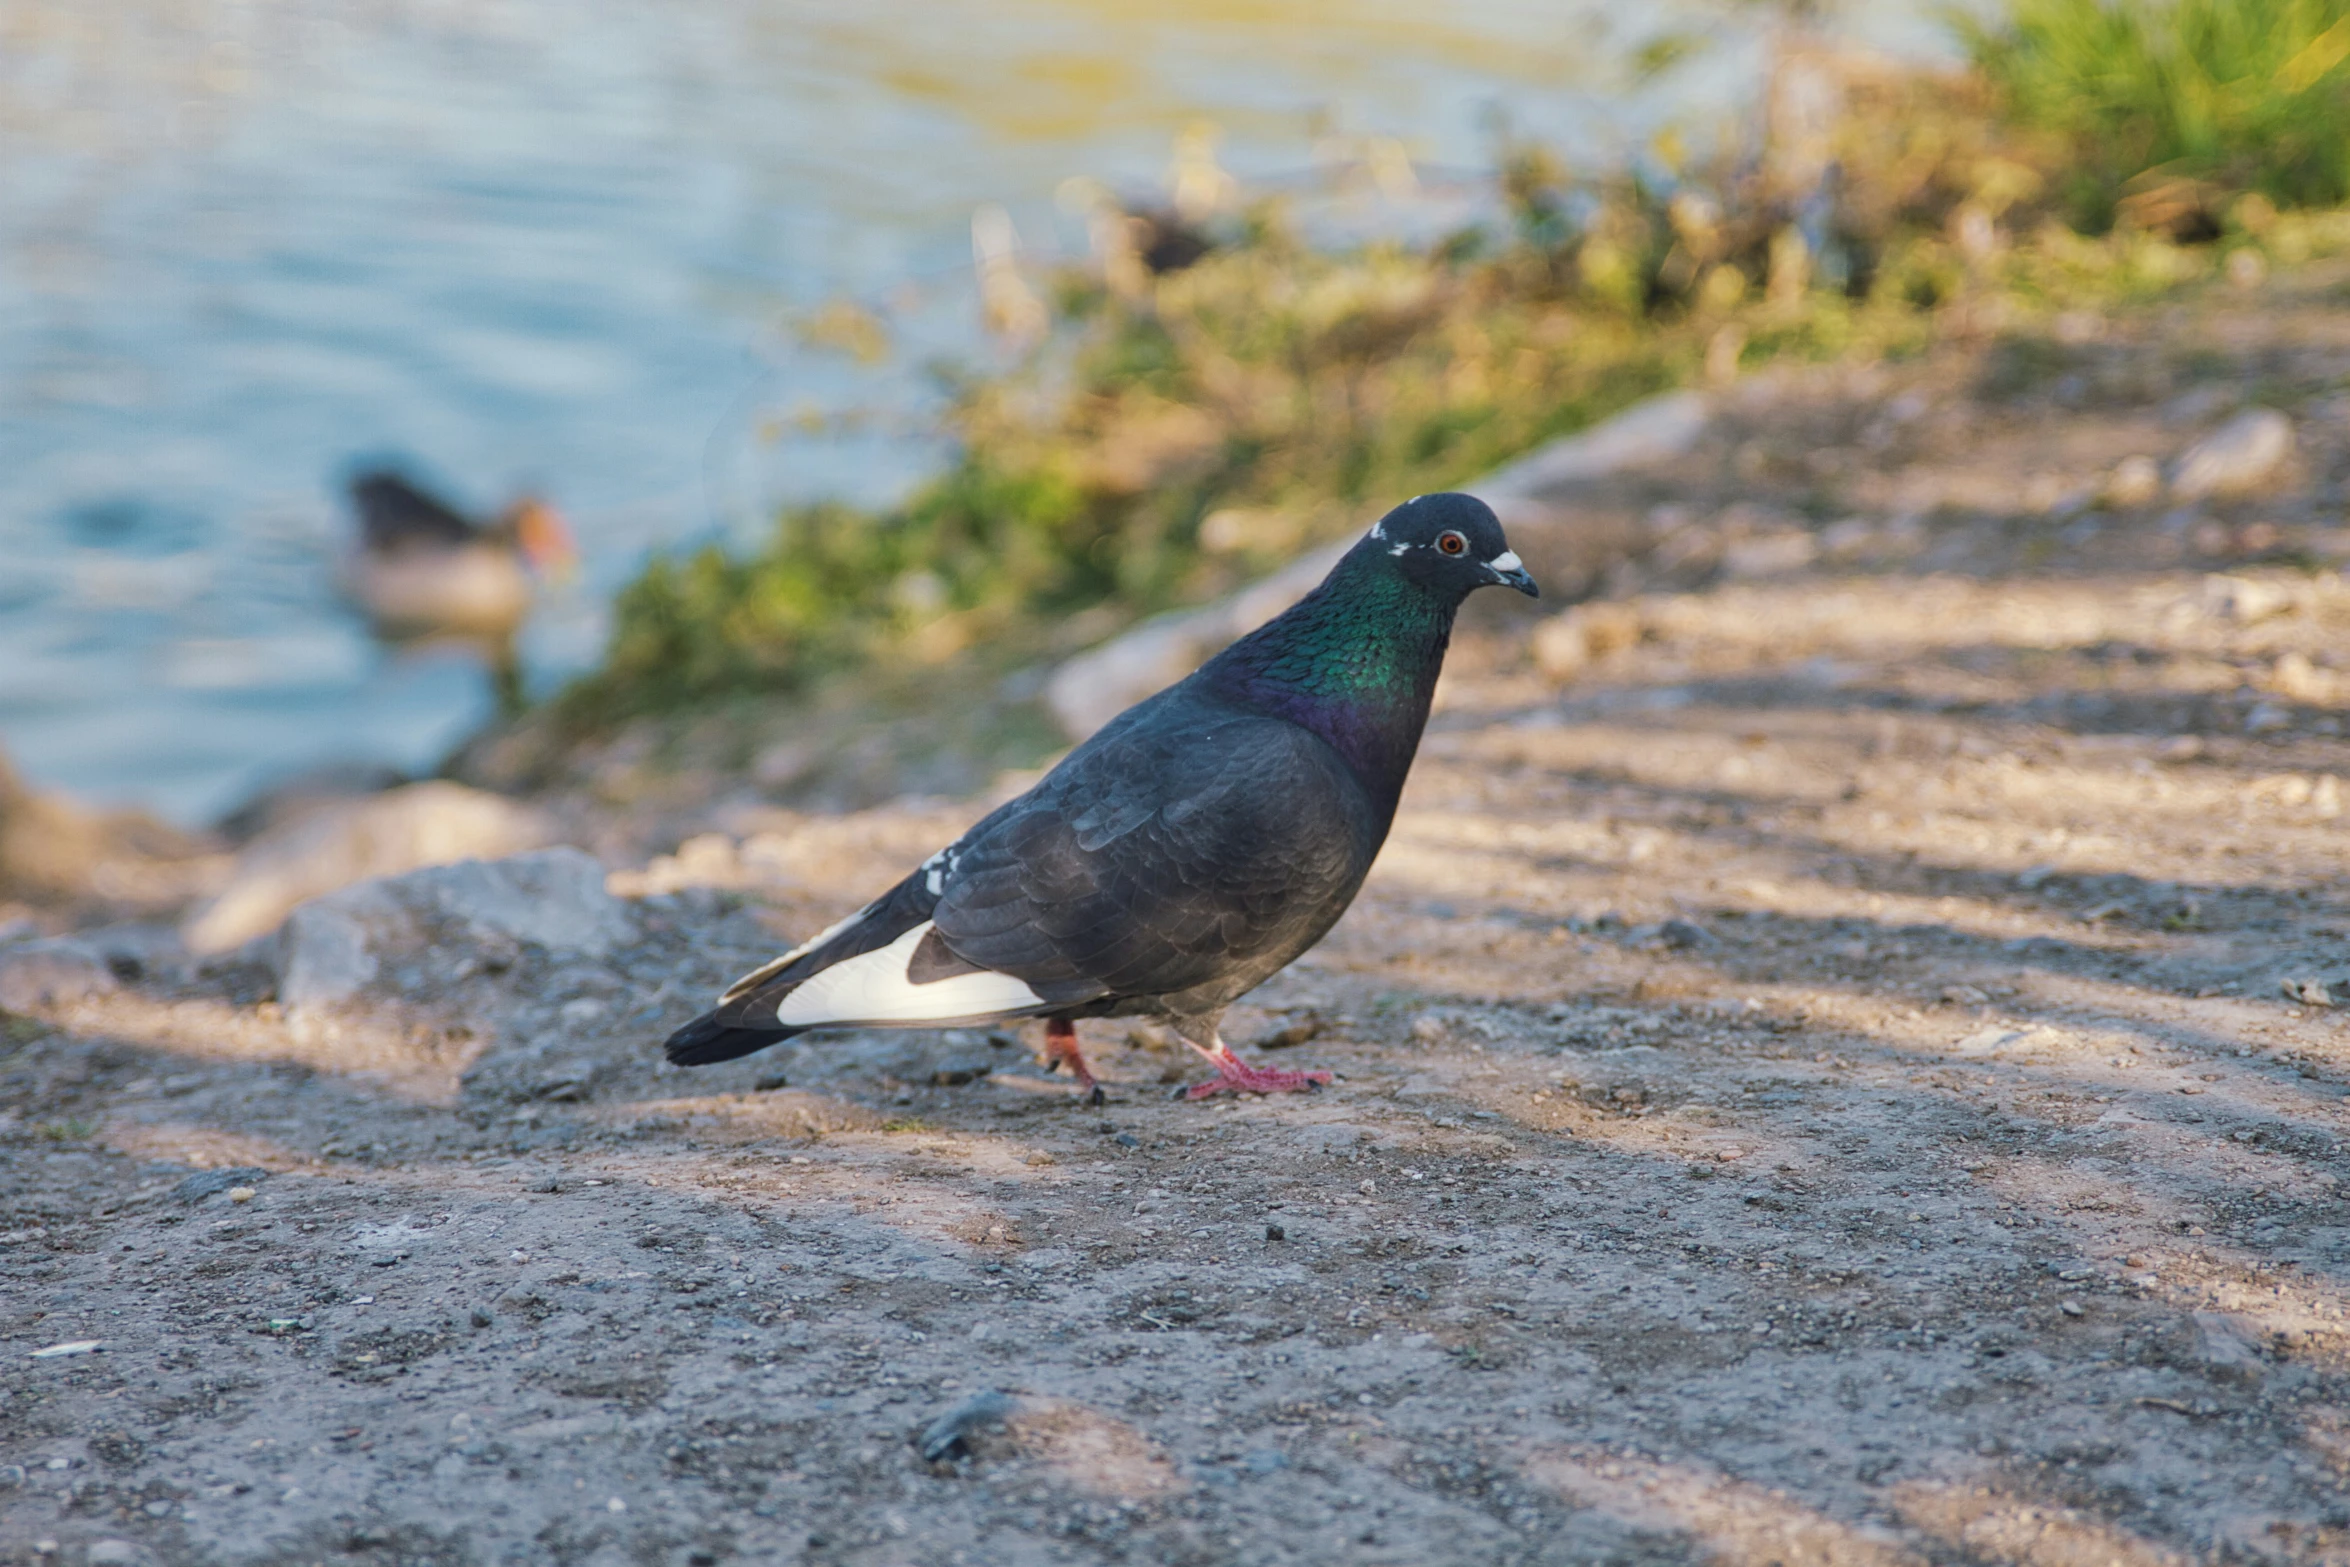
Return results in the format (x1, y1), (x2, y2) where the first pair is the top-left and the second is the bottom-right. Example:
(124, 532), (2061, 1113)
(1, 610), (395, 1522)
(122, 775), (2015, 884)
(343, 468), (578, 714)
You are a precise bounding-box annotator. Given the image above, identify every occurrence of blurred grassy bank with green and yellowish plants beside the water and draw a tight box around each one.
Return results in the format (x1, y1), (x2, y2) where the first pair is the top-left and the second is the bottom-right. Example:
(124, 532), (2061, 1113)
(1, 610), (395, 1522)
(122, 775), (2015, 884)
(552, 0), (2350, 733)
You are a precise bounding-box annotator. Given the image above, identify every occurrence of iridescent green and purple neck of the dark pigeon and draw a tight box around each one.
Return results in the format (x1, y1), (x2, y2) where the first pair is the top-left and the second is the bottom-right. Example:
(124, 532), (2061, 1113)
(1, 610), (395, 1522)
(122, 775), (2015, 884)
(1201, 545), (1459, 811)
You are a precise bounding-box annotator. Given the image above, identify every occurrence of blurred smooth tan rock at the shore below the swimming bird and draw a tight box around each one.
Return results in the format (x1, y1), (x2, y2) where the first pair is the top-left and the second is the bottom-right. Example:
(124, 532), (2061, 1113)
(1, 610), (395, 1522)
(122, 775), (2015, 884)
(181, 782), (552, 954)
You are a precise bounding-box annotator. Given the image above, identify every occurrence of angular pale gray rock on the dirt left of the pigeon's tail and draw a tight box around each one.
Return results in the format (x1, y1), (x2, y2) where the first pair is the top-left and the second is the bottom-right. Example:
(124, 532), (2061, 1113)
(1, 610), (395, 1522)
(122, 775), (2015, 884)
(275, 848), (635, 1008)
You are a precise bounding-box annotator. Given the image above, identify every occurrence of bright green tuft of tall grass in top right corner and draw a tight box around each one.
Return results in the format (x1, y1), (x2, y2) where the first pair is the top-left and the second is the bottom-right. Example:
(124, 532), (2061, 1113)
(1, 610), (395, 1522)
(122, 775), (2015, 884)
(1958, 0), (2350, 228)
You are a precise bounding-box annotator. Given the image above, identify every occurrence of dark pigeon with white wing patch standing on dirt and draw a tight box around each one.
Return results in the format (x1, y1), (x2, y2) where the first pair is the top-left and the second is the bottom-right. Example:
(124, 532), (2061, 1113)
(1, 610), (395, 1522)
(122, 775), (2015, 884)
(667, 493), (1537, 1104)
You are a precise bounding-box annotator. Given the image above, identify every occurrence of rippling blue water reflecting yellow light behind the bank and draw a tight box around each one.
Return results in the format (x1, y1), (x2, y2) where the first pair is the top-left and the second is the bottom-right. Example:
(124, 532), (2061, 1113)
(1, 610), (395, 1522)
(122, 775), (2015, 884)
(0, 0), (1925, 822)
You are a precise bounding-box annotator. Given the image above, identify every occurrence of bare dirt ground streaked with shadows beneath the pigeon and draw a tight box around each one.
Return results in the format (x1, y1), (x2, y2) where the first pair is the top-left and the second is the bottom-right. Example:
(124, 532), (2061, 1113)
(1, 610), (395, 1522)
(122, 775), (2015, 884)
(0, 263), (2350, 1567)
